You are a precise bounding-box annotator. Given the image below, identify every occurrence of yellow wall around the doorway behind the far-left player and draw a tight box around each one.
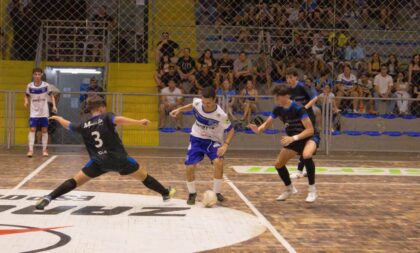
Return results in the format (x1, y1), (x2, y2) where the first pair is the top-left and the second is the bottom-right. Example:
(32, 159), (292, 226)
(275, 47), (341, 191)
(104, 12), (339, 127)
(0, 61), (159, 146)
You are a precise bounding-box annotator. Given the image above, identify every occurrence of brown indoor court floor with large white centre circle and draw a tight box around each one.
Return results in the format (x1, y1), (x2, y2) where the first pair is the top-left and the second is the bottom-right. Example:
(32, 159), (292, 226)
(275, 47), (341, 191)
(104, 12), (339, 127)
(0, 148), (420, 252)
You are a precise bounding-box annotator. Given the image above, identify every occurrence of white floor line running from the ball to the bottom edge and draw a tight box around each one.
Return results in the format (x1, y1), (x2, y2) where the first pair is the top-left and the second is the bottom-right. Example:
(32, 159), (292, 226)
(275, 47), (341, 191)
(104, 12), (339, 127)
(223, 175), (296, 253)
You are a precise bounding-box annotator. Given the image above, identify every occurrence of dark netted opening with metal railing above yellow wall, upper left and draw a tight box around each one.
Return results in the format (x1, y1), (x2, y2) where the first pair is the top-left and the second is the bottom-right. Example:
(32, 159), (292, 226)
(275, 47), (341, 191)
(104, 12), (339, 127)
(0, 0), (147, 62)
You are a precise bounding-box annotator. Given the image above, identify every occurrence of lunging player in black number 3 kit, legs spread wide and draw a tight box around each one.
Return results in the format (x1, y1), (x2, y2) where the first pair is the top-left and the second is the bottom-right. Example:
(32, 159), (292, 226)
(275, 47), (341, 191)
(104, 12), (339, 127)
(35, 96), (175, 210)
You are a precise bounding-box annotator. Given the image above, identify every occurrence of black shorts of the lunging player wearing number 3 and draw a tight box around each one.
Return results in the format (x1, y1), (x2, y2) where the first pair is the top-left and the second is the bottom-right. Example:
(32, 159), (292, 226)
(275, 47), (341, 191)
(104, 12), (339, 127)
(82, 157), (140, 178)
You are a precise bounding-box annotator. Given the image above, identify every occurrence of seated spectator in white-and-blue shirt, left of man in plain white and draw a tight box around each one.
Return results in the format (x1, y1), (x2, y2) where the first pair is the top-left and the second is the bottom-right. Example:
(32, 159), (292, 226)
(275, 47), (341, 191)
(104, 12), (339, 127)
(336, 65), (359, 113)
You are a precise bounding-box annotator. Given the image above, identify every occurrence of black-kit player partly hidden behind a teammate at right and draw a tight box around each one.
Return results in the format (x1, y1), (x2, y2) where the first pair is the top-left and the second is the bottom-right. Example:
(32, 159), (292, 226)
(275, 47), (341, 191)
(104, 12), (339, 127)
(286, 69), (321, 178)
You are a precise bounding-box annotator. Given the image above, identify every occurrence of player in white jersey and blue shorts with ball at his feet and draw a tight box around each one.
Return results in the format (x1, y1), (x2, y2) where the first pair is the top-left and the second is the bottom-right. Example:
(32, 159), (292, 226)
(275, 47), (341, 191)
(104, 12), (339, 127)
(170, 87), (235, 205)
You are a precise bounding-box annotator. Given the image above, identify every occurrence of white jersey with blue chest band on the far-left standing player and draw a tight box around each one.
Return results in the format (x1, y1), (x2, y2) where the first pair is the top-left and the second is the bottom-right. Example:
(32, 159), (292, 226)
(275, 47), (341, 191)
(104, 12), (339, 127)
(26, 82), (51, 118)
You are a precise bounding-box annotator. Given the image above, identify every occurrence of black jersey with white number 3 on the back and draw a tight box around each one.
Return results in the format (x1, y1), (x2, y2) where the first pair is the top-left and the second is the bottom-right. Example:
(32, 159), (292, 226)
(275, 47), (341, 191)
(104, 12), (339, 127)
(69, 112), (128, 167)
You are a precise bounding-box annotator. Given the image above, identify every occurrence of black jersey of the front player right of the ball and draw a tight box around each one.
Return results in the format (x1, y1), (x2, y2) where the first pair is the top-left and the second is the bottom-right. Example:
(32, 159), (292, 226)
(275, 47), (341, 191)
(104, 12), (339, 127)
(271, 101), (309, 136)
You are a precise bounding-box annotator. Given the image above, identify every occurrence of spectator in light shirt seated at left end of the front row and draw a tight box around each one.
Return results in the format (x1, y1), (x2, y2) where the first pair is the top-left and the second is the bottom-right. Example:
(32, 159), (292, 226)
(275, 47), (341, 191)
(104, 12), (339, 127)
(159, 80), (183, 130)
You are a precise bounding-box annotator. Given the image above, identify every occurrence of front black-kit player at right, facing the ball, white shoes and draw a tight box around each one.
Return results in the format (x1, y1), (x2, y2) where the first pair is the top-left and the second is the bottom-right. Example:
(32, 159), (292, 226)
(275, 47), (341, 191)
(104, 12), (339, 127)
(249, 85), (318, 202)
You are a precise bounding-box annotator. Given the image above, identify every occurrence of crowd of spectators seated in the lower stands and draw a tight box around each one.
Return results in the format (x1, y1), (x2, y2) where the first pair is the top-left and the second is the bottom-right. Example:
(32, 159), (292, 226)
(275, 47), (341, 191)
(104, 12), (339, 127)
(155, 29), (420, 128)
